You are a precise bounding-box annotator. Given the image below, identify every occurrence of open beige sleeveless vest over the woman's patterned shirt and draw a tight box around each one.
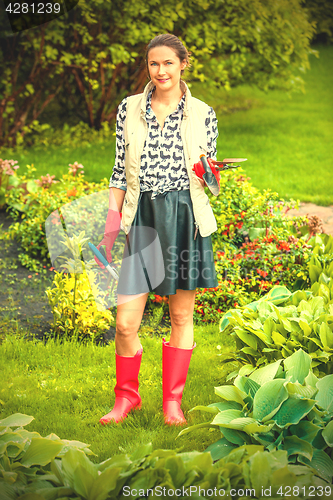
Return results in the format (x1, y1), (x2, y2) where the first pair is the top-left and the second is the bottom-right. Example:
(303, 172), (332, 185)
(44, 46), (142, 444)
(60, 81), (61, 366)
(121, 81), (217, 236)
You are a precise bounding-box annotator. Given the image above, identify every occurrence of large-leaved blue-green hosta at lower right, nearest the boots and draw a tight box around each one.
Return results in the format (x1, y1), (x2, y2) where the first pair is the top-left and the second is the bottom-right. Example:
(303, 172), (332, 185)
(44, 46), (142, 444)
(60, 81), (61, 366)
(180, 349), (333, 482)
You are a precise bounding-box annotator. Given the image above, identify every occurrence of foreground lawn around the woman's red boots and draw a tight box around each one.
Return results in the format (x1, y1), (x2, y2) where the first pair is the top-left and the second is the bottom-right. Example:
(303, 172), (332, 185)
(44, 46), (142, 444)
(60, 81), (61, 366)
(0, 325), (234, 462)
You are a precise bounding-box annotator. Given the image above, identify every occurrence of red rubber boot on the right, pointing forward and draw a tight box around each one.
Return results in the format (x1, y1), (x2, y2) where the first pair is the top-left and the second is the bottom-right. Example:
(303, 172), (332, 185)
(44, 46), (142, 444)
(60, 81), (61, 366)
(162, 339), (195, 425)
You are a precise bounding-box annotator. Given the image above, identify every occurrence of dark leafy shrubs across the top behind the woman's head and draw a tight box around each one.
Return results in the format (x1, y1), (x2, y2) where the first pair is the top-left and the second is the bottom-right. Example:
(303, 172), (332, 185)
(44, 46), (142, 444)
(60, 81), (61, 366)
(0, 0), (314, 144)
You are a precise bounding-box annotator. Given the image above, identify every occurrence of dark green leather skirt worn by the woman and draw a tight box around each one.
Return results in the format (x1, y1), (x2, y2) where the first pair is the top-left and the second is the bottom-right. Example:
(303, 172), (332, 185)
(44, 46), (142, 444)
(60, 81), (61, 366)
(117, 189), (218, 295)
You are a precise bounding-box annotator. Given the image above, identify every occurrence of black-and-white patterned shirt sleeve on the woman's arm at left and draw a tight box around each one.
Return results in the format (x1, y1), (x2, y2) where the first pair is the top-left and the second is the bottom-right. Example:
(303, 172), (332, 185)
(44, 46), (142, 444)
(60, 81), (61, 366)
(109, 98), (127, 191)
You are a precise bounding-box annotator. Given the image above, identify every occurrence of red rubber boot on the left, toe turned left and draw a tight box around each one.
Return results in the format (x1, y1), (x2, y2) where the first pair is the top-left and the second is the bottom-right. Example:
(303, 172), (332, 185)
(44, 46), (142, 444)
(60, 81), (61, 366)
(100, 348), (142, 425)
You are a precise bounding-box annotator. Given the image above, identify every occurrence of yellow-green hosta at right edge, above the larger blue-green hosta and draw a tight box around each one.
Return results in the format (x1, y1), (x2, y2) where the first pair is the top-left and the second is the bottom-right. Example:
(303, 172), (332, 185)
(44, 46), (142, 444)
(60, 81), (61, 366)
(220, 286), (333, 375)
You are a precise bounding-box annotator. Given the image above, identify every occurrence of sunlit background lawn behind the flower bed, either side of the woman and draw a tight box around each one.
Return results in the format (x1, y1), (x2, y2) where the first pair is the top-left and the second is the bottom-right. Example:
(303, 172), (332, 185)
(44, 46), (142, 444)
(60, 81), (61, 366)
(1, 46), (333, 205)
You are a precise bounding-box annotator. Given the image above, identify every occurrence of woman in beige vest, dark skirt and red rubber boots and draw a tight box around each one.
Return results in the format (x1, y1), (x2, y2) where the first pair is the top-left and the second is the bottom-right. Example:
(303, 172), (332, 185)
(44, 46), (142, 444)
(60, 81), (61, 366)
(99, 34), (218, 425)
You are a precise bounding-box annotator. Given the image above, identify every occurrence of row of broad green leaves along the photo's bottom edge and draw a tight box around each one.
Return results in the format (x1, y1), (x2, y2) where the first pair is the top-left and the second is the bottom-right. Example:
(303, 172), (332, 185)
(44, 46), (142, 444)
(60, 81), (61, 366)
(0, 414), (327, 500)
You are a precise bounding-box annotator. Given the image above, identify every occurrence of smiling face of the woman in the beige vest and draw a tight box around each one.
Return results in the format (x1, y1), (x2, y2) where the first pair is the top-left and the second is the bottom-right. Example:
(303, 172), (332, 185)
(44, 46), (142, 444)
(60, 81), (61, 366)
(148, 45), (186, 91)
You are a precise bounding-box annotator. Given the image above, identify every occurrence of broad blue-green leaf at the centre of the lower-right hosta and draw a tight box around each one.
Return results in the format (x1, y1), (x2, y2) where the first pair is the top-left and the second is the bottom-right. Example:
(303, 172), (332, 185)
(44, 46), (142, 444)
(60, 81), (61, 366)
(253, 379), (288, 421)
